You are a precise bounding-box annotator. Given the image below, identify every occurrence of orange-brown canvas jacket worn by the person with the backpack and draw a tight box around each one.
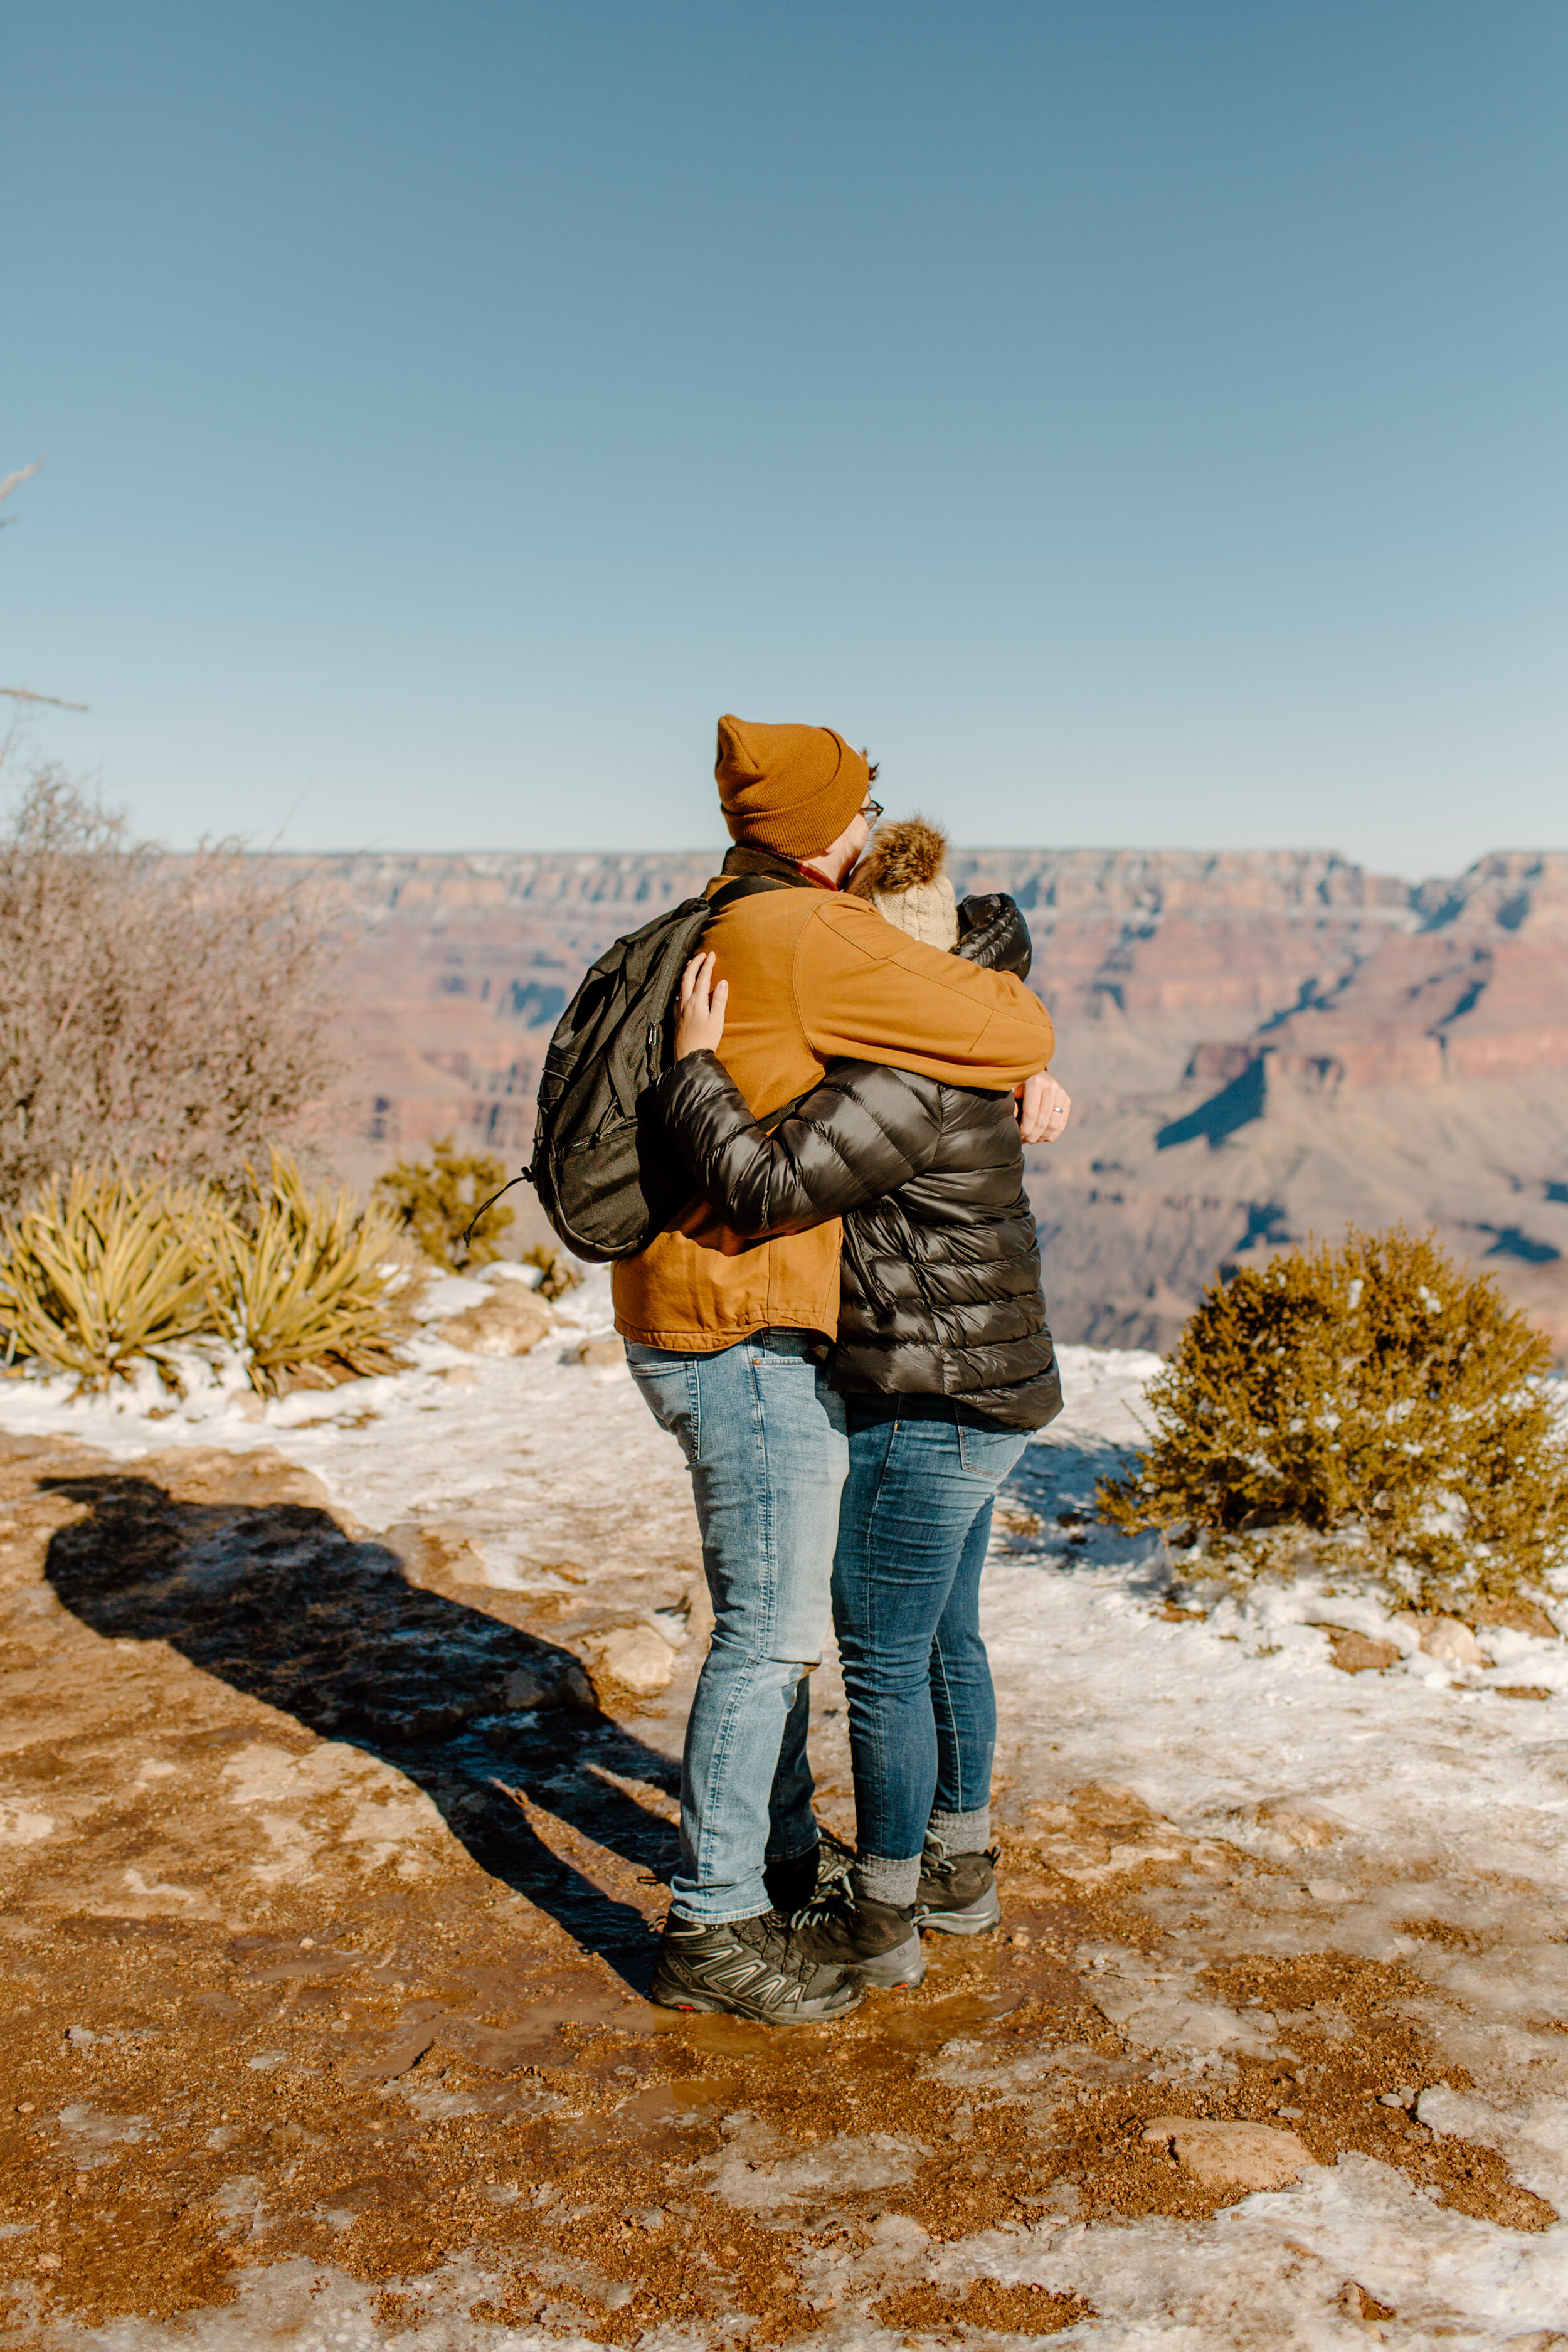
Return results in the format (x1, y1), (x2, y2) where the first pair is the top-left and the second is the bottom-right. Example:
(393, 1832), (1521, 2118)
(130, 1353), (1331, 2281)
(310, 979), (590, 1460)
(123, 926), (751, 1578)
(612, 880), (1056, 1355)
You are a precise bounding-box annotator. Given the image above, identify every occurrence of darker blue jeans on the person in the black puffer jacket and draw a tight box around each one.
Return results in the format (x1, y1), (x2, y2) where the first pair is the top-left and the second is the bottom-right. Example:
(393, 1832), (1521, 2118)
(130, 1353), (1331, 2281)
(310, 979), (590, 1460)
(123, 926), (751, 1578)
(832, 1397), (1030, 1860)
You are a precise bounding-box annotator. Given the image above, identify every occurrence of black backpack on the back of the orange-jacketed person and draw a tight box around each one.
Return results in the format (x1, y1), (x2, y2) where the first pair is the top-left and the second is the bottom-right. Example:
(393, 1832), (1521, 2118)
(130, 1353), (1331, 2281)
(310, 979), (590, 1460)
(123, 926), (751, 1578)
(495, 875), (790, 1263)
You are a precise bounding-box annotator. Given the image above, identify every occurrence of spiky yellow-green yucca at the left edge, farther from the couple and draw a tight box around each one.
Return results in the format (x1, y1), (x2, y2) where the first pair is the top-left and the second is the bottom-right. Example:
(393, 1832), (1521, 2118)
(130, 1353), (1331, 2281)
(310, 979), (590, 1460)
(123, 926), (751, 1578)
(0, 1167), (221, 1388)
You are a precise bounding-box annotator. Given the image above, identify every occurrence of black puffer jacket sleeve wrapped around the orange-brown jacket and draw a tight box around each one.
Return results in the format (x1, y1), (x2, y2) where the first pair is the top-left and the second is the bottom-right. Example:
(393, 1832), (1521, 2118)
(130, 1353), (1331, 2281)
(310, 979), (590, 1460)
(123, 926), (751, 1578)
(658, 1054), (943, 1239)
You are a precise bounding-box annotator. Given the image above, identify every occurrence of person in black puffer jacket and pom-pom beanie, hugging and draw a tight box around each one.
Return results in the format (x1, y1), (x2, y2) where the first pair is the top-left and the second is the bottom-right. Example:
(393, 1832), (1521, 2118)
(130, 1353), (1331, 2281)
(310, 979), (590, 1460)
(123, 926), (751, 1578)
(660, 828), (1065, 1983)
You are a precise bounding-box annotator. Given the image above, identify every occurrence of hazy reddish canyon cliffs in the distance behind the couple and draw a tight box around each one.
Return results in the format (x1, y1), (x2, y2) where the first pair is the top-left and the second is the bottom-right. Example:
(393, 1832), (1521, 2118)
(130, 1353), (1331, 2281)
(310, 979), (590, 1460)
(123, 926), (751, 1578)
(289, 849), (1568, 1350)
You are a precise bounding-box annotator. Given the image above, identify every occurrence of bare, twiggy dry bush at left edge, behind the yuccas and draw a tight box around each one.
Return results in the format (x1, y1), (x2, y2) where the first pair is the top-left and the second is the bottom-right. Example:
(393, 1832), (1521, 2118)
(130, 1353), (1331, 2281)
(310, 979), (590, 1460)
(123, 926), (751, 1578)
(0, 769), (336, 1202)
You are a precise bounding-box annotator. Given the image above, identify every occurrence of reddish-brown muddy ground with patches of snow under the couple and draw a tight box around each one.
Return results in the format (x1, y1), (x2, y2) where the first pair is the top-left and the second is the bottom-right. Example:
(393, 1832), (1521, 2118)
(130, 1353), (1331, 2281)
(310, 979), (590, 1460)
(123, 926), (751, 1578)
(0, 1286), (1568, 2352)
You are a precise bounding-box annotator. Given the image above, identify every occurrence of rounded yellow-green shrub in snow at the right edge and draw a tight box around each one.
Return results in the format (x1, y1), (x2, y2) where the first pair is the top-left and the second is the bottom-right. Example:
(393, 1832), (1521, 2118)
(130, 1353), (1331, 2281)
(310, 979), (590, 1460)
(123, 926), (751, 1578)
(1100, 1228), (1568, 1604)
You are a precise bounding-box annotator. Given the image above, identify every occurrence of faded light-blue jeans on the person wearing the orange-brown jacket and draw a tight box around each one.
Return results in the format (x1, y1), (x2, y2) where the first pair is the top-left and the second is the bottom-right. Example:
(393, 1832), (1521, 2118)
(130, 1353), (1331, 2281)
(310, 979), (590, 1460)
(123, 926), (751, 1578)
(625, 1329), (849, 1926)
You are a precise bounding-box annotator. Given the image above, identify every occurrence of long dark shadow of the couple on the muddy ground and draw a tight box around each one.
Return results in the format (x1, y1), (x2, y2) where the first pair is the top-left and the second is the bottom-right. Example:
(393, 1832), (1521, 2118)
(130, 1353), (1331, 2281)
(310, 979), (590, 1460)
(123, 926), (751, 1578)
(40, 1475), (679, 1992)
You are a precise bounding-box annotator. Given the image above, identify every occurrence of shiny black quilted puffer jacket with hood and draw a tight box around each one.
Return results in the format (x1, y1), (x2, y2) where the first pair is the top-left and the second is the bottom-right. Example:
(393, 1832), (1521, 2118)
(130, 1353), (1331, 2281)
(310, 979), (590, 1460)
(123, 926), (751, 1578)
(658, 899), (1062, 1430)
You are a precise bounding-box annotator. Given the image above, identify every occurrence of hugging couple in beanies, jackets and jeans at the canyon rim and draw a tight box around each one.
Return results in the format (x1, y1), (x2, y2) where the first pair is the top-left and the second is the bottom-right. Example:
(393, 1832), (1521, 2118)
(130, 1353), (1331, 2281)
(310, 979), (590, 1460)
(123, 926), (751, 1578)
(613, 718), (1069, 2025)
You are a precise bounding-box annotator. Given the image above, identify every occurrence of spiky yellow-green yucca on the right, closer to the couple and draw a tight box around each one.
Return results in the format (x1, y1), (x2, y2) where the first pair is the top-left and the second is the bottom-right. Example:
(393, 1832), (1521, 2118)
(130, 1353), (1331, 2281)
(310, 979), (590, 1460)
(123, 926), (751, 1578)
(211, 1153), (414, 1395)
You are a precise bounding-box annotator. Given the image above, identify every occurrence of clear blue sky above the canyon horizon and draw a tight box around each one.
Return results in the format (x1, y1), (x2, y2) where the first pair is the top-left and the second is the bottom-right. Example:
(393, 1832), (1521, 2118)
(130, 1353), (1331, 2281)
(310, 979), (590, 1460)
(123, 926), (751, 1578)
(0, 0), (1568, 875)
